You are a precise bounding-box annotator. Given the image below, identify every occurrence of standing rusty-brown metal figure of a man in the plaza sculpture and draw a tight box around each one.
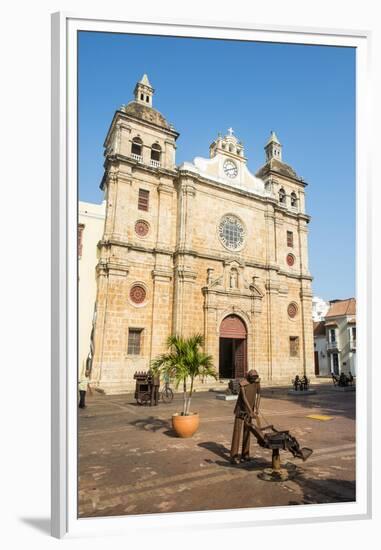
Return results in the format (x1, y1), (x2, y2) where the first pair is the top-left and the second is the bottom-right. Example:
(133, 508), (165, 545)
(230, 369), (261, 464)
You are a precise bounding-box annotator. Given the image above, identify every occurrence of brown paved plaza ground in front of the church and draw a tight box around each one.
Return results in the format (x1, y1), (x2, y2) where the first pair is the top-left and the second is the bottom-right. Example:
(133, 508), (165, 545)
(79, 384), (356, 517)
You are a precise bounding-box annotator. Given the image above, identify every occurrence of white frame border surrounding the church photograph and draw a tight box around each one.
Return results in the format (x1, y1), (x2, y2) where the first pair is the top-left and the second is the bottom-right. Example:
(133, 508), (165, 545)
(52, 13), (372, 538)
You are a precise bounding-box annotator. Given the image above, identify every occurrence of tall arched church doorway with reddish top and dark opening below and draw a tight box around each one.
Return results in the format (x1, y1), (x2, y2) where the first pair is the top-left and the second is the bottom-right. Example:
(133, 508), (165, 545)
(219, 315), (247, 378)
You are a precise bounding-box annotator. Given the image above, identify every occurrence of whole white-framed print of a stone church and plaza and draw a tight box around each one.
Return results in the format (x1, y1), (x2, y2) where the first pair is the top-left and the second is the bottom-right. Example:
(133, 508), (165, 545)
(52, 13), (371, 537)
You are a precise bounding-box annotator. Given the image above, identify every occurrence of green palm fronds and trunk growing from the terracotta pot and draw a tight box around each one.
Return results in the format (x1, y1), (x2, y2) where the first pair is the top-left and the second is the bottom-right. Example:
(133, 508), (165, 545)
(151, 334), (217, 416)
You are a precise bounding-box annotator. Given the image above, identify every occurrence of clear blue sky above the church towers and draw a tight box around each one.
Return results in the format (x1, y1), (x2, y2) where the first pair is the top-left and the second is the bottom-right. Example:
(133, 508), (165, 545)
(78, 32), (355, 300)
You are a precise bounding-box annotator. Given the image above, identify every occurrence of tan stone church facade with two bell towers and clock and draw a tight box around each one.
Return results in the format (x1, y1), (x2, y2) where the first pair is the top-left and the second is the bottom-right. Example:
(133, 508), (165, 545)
(92, 75), (314, 393)
